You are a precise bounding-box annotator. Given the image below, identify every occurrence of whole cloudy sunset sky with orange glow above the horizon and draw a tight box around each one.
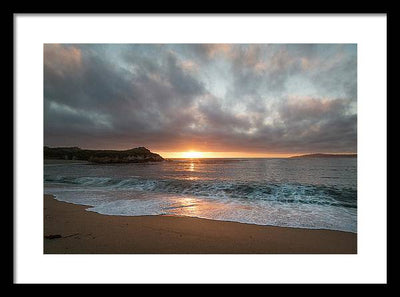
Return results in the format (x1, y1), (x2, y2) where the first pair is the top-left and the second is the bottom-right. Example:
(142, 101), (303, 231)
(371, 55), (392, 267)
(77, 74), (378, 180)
(44, 44), (357, 157)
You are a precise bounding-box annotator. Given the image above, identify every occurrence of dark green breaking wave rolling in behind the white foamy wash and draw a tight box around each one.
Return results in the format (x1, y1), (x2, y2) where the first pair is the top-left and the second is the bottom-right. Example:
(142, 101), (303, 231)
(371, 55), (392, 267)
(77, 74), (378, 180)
(44, 175), (357, 208)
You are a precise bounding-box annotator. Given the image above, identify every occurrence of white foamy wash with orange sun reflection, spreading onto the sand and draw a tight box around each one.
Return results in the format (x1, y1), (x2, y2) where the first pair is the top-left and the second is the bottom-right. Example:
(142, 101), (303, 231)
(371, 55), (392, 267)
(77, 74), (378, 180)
(46, 188), (357, 232)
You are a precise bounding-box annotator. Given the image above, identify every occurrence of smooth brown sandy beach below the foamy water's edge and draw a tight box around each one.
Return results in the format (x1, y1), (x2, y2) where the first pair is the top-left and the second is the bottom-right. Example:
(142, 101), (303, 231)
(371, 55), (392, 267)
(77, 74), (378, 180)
(44, 195), (357, 254)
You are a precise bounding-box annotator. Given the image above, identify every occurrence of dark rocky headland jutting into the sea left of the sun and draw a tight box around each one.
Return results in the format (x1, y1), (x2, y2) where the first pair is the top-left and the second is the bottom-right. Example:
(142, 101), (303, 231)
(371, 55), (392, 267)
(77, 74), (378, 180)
(44, 146), (164, 163)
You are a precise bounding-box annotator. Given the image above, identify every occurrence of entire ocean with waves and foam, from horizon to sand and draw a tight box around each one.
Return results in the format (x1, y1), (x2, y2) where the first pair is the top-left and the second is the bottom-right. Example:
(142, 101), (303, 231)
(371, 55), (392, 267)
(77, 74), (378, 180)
(44, 158), (357, 233)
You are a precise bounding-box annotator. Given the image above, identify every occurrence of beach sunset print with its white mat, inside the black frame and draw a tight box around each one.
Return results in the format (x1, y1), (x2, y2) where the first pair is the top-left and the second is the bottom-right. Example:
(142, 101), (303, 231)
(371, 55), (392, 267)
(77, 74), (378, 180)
(14, 14), (387, 283)
